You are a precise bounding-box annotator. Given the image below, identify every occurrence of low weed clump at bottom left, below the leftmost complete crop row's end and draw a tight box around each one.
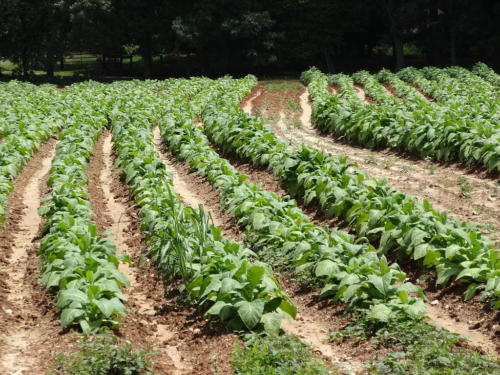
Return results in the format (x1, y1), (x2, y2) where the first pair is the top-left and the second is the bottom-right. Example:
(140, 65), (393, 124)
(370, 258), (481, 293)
(45, 335), (158, 375)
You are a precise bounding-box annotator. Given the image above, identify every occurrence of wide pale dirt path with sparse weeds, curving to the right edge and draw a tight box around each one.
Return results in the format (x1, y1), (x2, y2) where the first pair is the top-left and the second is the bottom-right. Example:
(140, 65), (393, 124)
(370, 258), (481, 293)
(247, 90), (500, 245)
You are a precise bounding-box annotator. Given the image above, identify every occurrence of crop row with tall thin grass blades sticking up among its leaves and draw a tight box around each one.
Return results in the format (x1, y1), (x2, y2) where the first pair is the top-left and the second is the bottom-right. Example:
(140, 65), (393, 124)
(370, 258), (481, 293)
(111, 79), (296, 332)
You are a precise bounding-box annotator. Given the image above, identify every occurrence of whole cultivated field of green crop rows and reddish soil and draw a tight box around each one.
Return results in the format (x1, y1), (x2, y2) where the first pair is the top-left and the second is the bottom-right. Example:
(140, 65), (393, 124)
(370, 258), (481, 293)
(0, 63), (500, 375)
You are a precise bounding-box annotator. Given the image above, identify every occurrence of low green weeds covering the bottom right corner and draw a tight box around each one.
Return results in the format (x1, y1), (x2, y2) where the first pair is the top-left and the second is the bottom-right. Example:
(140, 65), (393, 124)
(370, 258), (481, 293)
(331, 317), (500, 375)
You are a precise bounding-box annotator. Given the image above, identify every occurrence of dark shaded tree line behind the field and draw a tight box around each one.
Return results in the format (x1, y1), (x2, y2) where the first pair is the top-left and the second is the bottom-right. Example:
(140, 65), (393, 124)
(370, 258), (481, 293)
(0, 0), (500, 76)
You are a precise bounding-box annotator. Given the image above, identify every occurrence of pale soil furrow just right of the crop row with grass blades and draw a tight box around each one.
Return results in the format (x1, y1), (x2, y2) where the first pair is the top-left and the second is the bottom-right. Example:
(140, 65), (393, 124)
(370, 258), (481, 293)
(150, 128), (361, 369)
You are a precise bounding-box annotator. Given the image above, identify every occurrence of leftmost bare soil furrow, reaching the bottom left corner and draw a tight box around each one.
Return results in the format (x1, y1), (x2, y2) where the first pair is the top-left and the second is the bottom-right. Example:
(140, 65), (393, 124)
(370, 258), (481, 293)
(0, 138), (72, 375)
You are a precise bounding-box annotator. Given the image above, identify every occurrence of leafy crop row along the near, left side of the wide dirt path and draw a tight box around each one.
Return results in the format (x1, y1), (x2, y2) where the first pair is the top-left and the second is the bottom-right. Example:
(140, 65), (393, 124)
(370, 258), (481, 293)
(203, 79), (500, 307)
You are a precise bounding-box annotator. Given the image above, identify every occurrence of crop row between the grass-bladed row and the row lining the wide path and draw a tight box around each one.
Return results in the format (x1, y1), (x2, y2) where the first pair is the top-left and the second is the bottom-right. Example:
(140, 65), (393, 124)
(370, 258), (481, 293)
(159, 77), (425, 321)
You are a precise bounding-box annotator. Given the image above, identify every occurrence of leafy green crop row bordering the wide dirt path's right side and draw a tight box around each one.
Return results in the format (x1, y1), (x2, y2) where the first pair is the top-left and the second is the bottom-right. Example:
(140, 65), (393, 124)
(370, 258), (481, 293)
(302, 68), (500, 171)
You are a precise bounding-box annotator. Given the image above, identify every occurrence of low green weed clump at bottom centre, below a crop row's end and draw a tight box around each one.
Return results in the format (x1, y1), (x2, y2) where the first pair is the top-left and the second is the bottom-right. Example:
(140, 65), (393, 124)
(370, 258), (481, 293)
(231, 335), (331, 375)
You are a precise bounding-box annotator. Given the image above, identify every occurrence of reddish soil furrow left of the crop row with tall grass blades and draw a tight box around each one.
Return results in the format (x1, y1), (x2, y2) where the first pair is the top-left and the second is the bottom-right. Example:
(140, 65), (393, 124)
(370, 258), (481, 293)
(85, 131), (239, 375)
